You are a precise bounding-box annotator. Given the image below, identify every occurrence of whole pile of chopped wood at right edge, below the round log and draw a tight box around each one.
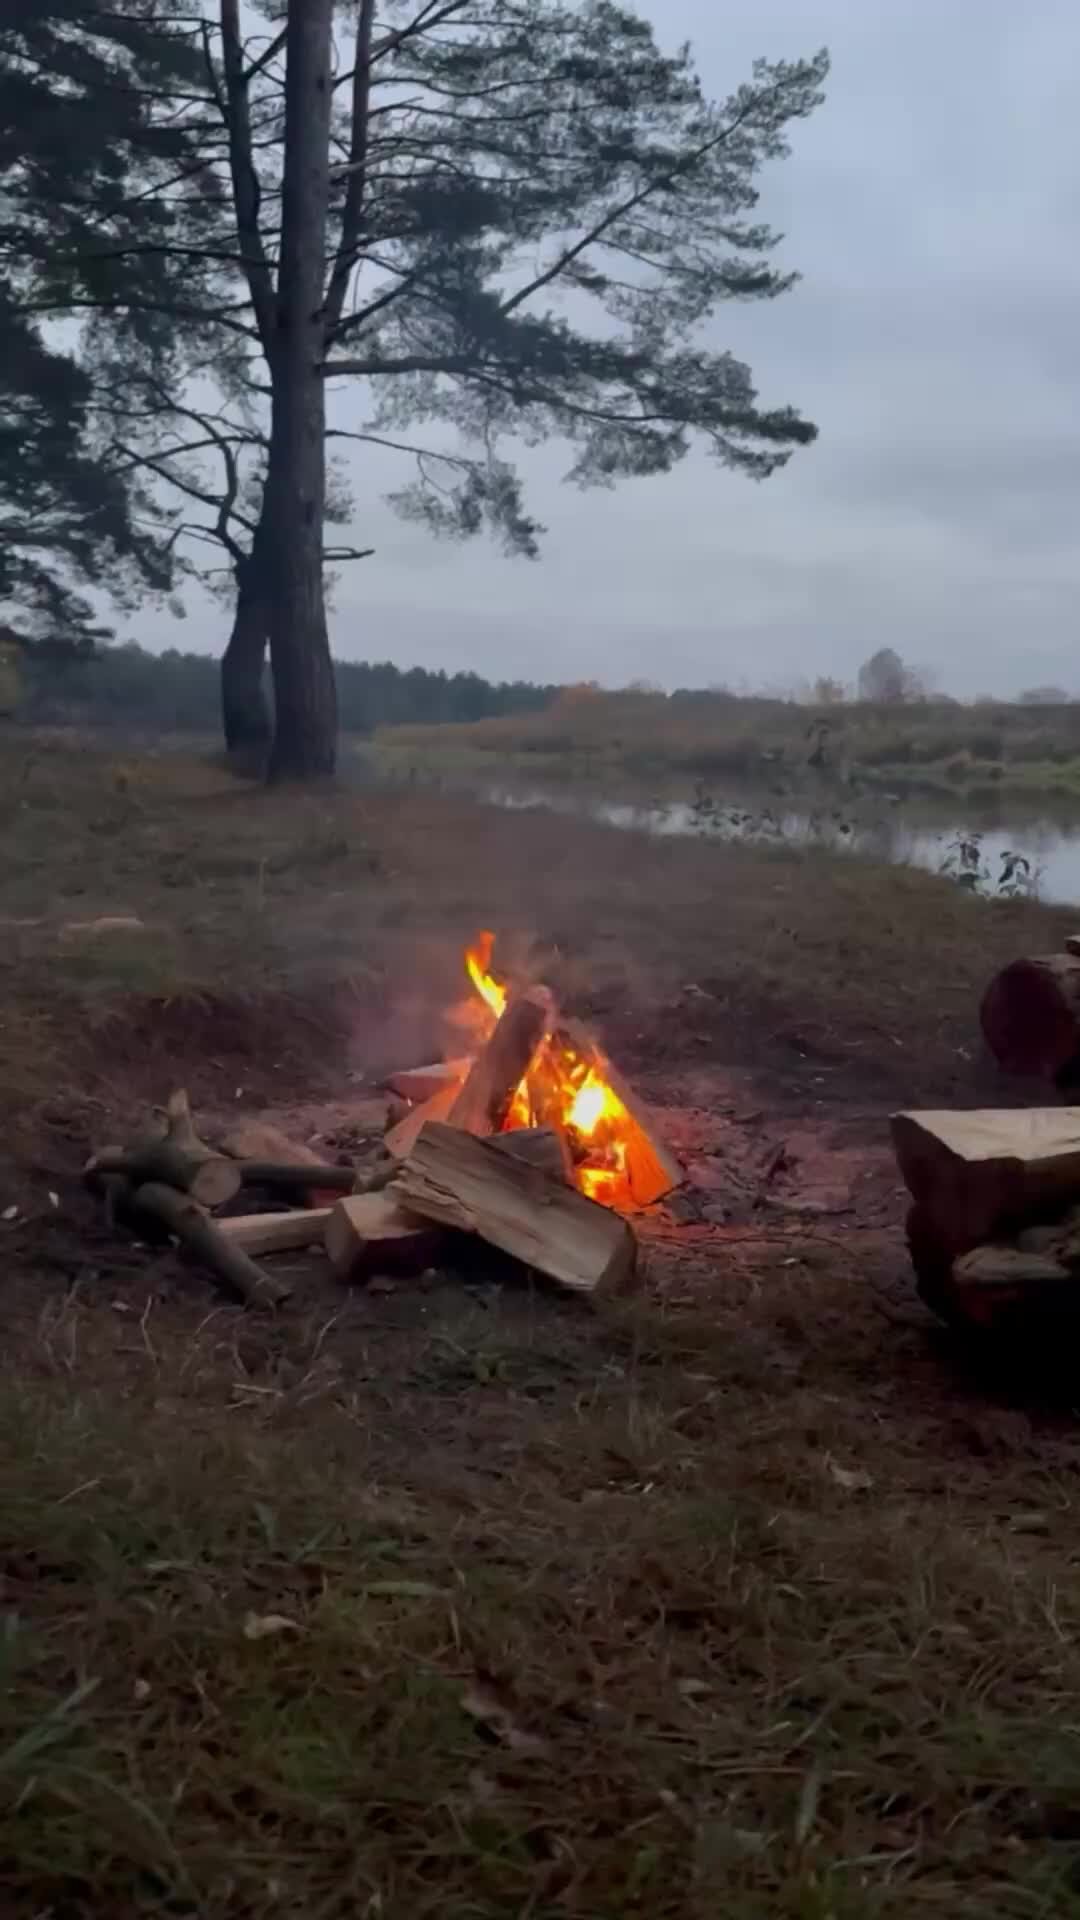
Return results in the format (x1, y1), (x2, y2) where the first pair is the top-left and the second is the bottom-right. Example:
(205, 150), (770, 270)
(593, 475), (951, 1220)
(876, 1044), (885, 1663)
(892, 1106), (1080, 1332)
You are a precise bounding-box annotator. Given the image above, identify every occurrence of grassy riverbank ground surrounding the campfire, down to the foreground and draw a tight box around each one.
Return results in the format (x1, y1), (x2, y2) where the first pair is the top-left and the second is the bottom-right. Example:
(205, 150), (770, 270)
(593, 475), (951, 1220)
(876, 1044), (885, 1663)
(0, 725), (1080, 1920)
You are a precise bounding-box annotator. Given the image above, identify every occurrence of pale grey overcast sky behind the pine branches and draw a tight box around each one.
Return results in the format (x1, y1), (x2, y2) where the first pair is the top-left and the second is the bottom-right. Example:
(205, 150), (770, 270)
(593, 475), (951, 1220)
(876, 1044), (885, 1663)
(145, 0), (1080, 695)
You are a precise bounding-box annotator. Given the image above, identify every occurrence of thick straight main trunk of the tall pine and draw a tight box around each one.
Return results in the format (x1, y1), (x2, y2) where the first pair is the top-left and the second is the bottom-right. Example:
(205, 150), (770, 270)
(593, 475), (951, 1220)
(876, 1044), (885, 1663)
(263, 0), (338, 781)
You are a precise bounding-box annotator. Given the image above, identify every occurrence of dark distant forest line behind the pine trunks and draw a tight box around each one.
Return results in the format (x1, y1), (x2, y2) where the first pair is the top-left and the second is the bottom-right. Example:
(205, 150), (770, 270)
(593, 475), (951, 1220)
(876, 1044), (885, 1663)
(12, 645), (557, 733)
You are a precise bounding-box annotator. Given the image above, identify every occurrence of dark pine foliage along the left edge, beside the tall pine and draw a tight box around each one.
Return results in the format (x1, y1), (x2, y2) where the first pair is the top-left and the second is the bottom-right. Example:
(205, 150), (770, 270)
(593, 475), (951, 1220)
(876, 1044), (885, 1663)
(0, 0), (217, 647)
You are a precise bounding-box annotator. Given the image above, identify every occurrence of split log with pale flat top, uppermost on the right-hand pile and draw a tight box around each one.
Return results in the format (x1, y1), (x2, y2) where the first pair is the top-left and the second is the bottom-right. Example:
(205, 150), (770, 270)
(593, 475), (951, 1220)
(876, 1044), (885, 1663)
(892, 1106), (1080, 1263)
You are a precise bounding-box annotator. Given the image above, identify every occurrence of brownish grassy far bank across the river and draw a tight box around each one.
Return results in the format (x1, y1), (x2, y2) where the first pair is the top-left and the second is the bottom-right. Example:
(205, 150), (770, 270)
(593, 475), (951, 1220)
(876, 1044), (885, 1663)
(379, 689), (1080, 799)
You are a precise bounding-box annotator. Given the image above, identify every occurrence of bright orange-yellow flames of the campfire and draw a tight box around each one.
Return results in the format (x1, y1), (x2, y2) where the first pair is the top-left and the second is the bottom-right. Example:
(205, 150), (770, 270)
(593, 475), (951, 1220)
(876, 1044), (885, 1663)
(457, 933), (634, 1206)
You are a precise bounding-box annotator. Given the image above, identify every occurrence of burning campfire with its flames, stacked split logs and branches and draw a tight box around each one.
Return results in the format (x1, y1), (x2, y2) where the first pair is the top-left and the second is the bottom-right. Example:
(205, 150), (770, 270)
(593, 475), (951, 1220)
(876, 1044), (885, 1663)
(85, 933), (680, 1306)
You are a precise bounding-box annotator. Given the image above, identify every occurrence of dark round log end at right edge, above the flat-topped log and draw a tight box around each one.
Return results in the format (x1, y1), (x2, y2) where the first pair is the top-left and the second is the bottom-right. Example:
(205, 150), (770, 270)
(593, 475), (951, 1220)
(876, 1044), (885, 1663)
(980, 952), (1080, 1079)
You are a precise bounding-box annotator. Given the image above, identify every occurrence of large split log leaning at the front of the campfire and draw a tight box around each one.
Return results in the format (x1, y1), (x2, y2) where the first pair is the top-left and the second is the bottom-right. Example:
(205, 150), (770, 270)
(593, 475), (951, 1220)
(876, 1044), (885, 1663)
(390, 1121), (636, 1294)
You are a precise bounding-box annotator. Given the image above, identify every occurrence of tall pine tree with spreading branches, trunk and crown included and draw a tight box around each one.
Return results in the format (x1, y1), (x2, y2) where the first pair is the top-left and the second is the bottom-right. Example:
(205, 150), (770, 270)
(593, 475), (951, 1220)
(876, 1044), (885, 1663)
(52, 0), (828, 778)
